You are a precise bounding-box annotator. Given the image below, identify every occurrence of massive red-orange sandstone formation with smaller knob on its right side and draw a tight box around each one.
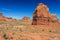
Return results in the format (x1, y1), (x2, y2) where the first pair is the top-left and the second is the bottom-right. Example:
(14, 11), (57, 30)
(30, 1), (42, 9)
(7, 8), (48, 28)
(32, 3), (58, 25)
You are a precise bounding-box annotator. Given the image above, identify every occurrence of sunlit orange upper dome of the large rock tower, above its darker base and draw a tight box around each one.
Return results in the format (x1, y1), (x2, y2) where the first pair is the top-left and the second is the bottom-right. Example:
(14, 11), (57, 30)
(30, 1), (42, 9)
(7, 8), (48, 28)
(36, 3), (50, 17)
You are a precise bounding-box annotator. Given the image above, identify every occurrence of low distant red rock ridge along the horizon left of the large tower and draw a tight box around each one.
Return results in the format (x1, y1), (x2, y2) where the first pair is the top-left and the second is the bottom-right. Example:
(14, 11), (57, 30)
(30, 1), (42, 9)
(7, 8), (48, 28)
(0, 13), (31, 22)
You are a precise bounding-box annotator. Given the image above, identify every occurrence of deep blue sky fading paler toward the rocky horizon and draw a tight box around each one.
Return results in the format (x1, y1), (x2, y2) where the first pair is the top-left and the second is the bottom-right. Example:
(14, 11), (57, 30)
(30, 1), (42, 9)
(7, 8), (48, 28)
(0, 0), (60, 19)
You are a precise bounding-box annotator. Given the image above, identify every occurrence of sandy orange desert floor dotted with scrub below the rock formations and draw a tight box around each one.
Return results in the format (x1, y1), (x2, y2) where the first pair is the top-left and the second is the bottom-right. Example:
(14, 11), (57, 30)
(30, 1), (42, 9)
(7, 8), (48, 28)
(0, 21), (60, 40)
